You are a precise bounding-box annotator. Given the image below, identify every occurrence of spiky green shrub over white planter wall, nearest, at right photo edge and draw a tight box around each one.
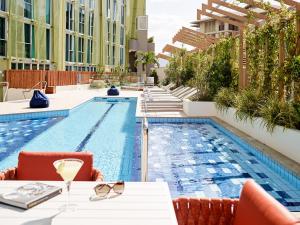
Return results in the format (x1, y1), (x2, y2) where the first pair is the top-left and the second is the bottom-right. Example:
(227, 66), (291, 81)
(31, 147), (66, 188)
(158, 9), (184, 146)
(261, 97), (300, 132)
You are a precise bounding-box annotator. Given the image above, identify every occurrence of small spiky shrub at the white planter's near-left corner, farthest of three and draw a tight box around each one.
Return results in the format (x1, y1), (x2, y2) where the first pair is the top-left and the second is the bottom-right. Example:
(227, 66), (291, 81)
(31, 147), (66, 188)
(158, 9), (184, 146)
(215, 88), (236, 112)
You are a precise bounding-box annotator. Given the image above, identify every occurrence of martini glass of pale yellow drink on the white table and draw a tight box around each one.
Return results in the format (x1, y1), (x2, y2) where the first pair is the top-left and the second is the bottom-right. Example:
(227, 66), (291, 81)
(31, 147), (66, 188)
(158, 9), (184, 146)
(53, 159), (83, 211)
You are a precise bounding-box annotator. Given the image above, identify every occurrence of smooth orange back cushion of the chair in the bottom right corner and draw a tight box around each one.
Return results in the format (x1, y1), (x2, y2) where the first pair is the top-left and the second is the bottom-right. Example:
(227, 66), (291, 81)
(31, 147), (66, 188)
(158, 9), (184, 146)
(234, 180), (300, 225)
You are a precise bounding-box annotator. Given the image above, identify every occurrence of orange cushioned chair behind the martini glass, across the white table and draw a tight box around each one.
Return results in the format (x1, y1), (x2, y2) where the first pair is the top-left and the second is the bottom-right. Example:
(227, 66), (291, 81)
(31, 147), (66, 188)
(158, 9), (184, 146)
(0, 152), (103, 181)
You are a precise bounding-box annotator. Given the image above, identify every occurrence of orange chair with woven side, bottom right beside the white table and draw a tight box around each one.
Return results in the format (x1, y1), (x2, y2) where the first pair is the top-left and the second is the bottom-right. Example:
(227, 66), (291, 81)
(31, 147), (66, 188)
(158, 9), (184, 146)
(173, 180), (300, 225)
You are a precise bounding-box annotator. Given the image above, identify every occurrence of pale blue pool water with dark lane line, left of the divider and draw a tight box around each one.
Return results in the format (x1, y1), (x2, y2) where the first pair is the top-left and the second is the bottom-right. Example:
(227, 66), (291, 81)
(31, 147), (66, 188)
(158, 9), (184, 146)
(0, 99), (137, 181)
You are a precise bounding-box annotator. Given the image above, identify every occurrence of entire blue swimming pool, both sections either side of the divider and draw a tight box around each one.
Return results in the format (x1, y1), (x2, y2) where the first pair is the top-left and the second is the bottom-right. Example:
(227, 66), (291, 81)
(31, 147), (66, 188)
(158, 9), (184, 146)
(0, 98), (300, 211)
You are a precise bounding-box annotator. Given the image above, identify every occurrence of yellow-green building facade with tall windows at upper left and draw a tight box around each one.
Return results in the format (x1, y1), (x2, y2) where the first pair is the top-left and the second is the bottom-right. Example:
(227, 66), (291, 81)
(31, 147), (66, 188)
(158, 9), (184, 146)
(0, 0), (145, 71)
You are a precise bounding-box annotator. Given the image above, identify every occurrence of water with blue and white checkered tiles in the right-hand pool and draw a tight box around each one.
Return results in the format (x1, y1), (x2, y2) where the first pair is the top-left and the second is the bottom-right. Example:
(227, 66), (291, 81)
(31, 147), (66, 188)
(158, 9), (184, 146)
(148, 122), (300, 211)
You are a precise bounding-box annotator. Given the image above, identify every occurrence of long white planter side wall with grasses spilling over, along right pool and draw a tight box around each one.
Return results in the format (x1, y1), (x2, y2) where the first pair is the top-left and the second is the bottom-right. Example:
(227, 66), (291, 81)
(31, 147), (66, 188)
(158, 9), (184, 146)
(217, 108), (300, 163)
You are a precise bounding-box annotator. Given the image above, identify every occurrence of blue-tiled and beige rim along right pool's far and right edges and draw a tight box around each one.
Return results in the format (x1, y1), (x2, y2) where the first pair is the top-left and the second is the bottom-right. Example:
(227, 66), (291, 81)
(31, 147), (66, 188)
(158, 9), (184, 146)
(137, 117), (300, 188)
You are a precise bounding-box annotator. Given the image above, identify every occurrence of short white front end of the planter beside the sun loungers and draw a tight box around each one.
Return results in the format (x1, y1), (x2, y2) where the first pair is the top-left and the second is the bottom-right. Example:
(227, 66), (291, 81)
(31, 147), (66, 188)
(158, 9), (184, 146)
(183, 99), (217, 117)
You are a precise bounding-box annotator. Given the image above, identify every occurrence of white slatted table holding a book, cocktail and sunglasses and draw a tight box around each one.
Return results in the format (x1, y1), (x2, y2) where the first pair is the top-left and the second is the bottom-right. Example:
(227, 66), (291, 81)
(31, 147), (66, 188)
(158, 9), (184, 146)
(0, 181), (177, 225)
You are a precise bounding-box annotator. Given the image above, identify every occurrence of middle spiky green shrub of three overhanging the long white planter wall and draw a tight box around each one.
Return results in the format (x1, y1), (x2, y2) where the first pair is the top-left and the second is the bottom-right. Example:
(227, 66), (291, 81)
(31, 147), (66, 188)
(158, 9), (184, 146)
(235, 88), (265, 120)
